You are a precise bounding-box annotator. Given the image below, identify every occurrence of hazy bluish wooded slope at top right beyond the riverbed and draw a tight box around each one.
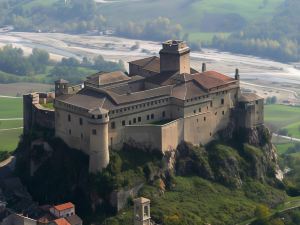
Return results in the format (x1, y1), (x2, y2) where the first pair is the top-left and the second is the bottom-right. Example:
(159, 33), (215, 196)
(210, 0), (300, 62)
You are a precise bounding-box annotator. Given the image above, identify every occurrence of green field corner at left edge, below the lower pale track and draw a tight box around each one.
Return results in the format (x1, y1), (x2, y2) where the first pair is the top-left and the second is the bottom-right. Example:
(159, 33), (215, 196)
(0, 129), (23, 151)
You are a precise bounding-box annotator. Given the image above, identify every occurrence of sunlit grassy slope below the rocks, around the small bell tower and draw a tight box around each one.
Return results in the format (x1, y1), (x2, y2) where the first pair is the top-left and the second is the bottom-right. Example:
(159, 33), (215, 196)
(106, 177), (284, 225)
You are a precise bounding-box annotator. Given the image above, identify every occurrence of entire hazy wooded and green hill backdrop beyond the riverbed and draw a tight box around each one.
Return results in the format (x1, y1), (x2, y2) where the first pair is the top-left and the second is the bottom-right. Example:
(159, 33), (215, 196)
(0, 0), (300, 61)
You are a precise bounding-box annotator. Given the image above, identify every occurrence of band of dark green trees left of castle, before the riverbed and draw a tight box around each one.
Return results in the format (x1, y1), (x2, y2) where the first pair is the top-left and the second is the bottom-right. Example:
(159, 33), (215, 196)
(0, 45), (125, 83)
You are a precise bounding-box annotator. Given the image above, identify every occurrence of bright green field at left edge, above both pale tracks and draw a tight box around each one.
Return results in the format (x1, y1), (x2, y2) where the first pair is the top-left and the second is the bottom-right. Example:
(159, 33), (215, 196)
(0, 97), (23, 119)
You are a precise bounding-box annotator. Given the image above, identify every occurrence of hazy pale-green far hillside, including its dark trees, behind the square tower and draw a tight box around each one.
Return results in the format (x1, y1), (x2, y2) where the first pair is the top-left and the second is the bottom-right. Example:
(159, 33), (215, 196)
(100, 0), (283, 41)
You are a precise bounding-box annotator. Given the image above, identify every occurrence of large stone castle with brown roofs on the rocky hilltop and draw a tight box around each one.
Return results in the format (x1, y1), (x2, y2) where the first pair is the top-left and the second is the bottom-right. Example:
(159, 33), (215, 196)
(24, 40), (264, 172)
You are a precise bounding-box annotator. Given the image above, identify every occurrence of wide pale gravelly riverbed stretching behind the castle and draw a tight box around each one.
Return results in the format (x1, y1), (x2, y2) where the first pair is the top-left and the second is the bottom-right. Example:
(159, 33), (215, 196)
(0, 32), (300, 84)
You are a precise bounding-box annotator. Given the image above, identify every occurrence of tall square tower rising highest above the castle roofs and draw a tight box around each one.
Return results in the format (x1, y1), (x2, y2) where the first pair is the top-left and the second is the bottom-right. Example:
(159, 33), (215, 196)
(159, 40), (191, 74)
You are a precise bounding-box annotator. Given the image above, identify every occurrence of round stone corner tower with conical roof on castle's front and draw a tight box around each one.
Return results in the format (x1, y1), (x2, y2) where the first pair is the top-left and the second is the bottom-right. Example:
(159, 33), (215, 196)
(89, 108), (109, 173)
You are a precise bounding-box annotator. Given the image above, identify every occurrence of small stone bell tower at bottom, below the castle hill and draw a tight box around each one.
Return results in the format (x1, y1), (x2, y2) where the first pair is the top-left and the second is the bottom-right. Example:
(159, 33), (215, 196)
(134, 198), (151, 225)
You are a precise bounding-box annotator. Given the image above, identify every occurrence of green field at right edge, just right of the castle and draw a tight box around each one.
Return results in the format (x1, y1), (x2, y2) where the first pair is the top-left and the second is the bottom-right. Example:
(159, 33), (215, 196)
(265, 105), (300, 138)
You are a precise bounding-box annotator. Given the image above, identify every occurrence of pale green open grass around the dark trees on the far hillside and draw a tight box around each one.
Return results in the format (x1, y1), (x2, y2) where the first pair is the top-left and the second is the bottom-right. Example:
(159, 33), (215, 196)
(101, 0), (283, 41)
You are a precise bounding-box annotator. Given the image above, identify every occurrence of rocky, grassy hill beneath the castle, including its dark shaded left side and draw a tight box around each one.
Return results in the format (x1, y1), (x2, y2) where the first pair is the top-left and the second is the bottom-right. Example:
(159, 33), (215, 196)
(17, 123), (287, 225)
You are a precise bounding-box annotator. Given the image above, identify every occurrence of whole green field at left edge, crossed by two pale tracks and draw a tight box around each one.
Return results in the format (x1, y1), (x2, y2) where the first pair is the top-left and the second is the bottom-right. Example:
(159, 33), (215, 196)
(0, 97), (23, 152)
